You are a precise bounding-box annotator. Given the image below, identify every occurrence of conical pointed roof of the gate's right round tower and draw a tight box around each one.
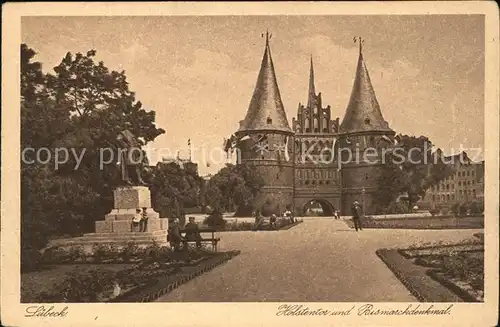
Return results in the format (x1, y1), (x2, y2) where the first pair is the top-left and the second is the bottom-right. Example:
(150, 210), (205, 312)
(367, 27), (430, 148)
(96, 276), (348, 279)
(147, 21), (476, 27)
(340, 38), (392, 133)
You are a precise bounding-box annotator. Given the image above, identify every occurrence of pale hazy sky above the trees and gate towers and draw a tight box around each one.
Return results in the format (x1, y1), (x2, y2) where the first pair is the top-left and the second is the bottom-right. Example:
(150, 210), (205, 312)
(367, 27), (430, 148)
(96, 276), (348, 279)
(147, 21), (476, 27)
(21, 15), (485, 175)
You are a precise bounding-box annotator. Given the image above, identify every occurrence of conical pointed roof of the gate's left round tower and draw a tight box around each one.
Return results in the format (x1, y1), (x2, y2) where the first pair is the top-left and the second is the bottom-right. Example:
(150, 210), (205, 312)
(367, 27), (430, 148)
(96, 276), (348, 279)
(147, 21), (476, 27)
(238, 33), (292, 133)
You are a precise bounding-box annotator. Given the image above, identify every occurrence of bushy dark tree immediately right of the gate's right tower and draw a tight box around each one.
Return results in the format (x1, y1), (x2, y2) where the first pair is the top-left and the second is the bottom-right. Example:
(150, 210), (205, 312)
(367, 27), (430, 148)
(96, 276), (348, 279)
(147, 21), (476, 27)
(375, 135), (451, 210)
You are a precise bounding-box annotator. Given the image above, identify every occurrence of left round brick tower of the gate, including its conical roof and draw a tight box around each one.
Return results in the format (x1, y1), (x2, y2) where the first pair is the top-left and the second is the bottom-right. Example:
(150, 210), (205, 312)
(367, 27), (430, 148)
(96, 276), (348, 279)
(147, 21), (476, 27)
(235, 33), (294, 213)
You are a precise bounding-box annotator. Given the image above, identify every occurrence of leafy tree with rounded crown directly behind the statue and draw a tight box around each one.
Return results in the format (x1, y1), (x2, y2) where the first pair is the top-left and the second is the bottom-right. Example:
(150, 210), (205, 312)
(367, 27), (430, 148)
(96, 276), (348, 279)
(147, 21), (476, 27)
(47, 50), (165, 228)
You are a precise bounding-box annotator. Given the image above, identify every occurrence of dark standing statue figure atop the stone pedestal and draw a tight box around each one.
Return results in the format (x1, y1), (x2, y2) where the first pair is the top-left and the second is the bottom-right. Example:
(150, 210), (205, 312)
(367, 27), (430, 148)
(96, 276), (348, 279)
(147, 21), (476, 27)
(116, 129), (147, 185)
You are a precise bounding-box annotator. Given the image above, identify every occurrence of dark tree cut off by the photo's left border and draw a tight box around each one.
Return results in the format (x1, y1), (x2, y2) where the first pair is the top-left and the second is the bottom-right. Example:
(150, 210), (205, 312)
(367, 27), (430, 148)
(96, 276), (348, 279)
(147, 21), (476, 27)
(20, 44), (83, 269)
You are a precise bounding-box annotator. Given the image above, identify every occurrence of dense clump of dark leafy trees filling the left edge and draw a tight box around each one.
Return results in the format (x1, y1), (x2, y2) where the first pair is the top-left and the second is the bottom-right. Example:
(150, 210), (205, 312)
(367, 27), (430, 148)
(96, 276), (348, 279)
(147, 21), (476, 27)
(20, 44), (164, 272)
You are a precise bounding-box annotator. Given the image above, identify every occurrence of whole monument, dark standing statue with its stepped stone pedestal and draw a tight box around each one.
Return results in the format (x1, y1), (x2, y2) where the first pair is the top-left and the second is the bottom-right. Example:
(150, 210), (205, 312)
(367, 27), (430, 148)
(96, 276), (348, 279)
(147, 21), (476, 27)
(50, 130), (168, 247)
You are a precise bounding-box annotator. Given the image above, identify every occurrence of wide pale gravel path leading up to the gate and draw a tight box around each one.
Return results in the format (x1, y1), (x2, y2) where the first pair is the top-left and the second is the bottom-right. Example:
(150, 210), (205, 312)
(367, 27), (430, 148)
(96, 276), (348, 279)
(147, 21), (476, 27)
(158, 218), (479, 302)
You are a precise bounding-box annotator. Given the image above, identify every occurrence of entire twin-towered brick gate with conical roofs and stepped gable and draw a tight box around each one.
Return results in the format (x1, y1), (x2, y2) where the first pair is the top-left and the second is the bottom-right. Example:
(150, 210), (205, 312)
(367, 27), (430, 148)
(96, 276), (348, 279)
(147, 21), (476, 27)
(226, 33), (395, 215)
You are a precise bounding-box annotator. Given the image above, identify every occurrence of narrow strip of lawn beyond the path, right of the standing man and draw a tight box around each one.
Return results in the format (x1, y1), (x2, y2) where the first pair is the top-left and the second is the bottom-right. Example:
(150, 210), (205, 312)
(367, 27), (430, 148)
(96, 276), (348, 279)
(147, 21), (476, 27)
(344, 216), (484, 229)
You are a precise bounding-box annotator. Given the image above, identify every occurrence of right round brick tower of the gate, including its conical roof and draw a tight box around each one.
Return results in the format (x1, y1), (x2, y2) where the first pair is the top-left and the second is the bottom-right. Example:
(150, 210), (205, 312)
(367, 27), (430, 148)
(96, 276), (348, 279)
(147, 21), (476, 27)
(338, 38), (395, 215)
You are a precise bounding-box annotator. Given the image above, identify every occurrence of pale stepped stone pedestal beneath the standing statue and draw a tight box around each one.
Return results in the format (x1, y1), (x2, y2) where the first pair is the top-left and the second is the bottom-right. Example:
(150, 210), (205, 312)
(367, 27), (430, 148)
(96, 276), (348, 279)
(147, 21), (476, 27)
(49, 186), (168, 248)
